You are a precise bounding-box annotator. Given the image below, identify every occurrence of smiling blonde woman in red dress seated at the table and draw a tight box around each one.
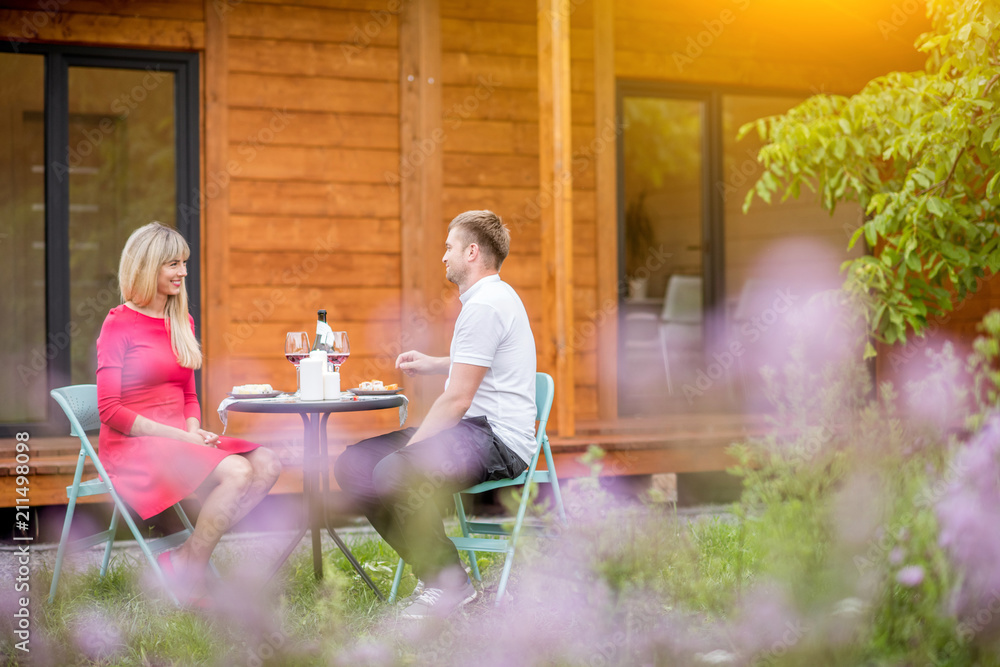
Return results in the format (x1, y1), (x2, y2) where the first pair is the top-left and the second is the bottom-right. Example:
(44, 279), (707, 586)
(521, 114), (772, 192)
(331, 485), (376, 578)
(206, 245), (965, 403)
(97, 222), (281, 604)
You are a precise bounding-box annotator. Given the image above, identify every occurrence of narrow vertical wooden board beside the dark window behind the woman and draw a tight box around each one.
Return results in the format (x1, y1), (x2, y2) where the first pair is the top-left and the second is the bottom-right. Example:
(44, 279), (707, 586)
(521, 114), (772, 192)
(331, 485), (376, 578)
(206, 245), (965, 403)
(200, 0), (233, 418)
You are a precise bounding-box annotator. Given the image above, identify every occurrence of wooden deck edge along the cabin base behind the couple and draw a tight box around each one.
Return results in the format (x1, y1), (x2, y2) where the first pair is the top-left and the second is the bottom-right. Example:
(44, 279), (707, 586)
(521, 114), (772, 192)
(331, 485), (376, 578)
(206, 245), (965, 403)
(0, 414), (764, 507)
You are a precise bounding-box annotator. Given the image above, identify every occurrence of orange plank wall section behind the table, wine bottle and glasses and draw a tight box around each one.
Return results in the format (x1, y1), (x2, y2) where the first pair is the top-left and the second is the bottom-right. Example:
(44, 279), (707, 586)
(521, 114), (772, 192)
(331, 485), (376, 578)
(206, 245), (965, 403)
(220, 1), (401, 437)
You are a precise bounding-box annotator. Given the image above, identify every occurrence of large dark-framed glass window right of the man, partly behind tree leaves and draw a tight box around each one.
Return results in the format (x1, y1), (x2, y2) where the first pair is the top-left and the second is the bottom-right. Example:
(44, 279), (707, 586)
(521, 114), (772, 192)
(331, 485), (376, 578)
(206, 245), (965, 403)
(618, 83), (862, 415)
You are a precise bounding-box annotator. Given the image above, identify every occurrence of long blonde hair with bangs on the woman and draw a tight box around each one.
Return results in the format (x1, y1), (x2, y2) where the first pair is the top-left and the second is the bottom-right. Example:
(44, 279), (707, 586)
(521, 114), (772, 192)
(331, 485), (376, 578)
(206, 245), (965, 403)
(118, 222), (201, 368)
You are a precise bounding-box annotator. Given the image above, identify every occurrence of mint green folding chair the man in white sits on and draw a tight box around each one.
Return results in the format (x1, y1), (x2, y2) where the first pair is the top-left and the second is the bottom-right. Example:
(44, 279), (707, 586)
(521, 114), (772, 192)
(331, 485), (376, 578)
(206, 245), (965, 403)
(389, 373), (566, 606)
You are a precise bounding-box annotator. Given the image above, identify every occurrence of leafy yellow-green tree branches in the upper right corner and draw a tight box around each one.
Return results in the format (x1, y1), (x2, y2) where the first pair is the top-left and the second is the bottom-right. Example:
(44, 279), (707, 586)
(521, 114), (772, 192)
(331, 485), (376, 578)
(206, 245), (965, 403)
(740, 0), (1000, 356)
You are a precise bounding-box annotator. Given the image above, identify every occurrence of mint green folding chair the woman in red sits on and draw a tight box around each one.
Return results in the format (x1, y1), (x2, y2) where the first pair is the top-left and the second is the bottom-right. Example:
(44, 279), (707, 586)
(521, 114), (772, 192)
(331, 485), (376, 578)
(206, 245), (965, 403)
(49, 384), (204, 603)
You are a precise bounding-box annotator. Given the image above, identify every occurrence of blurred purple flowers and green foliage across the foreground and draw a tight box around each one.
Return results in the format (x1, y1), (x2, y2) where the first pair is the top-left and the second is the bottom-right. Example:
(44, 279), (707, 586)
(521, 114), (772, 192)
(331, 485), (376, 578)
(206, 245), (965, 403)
(9, 312), (1000, 665)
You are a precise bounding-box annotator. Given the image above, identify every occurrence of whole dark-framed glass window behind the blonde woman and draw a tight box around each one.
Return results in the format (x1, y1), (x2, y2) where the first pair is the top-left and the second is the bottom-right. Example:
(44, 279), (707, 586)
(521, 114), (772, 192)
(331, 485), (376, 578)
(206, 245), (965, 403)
(0, 44), (200, 436)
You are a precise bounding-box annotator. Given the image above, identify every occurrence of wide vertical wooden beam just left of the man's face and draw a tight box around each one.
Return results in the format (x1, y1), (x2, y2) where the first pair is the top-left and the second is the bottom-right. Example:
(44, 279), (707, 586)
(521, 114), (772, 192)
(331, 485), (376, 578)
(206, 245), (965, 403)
(399, 0), (444, 418)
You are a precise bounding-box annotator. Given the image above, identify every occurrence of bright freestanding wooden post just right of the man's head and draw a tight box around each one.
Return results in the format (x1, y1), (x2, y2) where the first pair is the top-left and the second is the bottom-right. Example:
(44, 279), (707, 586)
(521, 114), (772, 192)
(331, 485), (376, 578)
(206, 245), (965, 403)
(538, 0), (576, 435)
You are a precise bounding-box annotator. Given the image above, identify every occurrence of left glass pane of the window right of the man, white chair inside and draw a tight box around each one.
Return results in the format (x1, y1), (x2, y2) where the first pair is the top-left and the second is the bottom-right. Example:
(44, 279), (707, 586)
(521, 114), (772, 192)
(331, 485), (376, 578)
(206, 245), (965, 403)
(618, 95), (705, 415)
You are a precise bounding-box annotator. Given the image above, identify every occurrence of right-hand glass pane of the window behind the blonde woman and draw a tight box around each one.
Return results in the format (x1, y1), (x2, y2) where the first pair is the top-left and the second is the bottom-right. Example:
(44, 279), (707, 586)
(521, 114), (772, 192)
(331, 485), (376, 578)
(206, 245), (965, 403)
(65, 67), (177, 384)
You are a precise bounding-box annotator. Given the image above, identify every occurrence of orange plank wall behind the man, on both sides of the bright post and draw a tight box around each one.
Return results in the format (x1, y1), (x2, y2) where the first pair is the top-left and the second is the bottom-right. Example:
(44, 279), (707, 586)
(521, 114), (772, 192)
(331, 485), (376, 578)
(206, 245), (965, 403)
(441, 0), (597, 418)
